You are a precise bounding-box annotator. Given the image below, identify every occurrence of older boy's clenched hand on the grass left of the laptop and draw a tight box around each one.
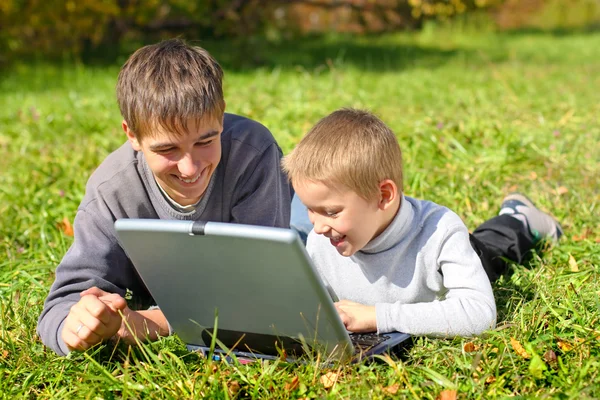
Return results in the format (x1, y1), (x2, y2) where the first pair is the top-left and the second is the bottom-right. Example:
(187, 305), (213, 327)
(61, 287), (127, 350)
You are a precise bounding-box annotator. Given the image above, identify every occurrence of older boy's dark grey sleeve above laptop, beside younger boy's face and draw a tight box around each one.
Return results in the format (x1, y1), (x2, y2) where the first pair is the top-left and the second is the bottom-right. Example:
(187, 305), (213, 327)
(231, 143), (292, 228)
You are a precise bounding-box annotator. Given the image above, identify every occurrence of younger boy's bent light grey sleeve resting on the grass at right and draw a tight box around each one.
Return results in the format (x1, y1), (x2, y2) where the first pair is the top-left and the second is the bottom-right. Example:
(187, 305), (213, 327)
(376, 226), (496, 337)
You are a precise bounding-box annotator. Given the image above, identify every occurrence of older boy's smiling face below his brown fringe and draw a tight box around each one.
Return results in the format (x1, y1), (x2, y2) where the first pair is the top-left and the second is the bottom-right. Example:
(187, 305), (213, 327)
(123, 117), (223, 206)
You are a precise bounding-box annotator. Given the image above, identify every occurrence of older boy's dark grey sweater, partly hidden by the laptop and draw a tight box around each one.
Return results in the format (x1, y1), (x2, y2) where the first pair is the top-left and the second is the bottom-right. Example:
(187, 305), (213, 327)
(38, 114), (291, 355)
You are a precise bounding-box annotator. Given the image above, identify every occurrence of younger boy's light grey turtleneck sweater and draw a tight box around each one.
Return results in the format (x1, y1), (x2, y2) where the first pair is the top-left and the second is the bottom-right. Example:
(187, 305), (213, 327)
(307, 196), (496, 336)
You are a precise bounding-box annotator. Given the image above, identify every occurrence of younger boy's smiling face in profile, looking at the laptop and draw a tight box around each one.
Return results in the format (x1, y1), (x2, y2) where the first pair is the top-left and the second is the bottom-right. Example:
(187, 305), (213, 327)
(294, 181), (382, 257)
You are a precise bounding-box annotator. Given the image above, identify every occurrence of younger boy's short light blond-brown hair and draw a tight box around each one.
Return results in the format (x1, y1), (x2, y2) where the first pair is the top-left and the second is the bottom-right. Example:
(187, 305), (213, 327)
(282, 108), (403, 200)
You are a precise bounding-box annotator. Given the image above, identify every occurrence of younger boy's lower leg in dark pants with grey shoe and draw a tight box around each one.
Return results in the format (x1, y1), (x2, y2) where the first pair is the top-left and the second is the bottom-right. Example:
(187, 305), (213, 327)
(471, 193), (562, 282)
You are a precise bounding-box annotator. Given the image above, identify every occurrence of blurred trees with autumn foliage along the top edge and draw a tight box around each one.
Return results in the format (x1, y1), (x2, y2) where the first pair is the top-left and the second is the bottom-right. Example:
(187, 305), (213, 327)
(0, 0), (600, 64)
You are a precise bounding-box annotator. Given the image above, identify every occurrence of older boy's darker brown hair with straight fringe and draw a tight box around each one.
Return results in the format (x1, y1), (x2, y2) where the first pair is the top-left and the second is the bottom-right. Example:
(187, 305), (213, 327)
(117, 39), (225, 140)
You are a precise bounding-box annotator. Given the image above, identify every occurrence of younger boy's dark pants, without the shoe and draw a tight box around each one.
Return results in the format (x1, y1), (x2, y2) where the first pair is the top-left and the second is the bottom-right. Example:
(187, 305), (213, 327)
(470, 215), (535, 282)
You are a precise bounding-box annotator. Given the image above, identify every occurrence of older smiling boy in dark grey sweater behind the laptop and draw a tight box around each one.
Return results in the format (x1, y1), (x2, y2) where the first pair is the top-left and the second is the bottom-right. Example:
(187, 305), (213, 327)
(38, 40), (291, 355)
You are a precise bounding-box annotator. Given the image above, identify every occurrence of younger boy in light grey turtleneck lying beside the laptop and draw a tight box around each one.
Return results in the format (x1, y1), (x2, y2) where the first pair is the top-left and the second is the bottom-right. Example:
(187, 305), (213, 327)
(283, 109), (562, 336)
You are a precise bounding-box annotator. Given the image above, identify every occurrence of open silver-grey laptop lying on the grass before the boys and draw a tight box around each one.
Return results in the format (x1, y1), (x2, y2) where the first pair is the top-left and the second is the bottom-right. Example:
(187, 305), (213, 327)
(115, 219), (410, 361)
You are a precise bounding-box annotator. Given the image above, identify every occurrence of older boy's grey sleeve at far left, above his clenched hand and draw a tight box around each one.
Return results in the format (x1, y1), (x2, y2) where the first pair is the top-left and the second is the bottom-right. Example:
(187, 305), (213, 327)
(37, 209), (131, 355)
